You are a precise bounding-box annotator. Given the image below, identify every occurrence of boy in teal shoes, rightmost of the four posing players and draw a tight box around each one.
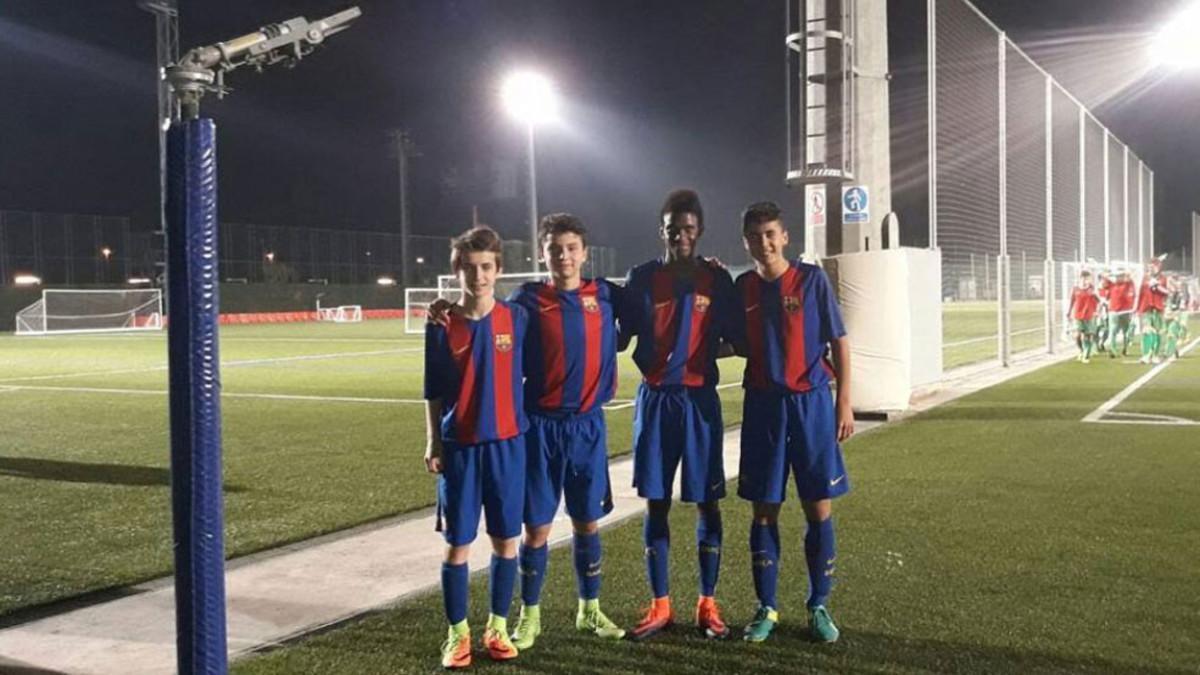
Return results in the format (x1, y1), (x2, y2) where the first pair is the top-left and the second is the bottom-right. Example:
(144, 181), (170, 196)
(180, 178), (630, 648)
(737, 202), (854, 643)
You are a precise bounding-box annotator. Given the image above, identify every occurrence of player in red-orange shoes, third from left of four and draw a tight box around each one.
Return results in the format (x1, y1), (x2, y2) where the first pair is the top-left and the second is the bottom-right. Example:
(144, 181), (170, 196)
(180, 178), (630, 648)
(620, 190), (742, 640)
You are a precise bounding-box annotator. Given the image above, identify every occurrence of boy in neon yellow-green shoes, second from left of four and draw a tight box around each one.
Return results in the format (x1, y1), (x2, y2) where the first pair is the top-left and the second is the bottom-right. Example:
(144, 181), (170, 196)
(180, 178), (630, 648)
(510, 214), (625, 650)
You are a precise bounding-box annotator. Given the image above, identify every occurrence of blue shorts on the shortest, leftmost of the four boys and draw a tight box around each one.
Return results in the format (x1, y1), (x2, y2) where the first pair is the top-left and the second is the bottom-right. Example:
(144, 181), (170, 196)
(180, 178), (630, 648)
(438, 435), (526, 546)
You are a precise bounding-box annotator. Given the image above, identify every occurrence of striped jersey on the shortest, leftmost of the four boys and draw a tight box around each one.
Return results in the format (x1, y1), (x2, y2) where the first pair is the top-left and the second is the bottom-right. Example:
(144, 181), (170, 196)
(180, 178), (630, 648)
(425, 300), (529, 446)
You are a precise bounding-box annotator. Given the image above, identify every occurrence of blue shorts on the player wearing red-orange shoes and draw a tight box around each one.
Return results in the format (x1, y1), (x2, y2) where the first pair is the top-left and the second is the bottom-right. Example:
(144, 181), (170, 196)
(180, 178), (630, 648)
(634, 383), (725, 503)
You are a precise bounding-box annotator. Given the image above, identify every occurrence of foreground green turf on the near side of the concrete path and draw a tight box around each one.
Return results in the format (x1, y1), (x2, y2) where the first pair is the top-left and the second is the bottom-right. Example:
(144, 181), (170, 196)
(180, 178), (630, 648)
(233, 343), (1200, 675)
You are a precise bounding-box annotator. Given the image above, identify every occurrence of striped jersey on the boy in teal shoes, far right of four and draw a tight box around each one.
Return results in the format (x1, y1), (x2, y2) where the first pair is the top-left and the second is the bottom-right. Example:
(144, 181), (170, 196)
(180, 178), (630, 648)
(737, 261), (846, 392)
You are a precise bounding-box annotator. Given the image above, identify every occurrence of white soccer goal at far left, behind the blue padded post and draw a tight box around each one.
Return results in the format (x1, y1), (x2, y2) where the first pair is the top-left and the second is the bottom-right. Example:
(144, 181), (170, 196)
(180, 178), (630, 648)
(17, 288), (163, 335)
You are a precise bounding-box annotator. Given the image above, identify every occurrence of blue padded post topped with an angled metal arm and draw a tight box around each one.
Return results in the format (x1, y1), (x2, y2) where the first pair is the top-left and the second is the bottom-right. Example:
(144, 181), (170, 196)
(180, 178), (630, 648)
(166, 7), (361, 675)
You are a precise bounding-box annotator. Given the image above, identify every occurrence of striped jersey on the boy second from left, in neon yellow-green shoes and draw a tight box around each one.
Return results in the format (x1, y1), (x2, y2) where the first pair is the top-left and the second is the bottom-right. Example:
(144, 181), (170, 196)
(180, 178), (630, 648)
(509, 279), (620, 413)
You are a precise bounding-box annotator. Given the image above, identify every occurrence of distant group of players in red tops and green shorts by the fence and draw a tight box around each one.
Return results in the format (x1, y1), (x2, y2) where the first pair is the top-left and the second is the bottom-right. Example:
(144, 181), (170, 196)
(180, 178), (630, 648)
(1067, 258), (1200, 363)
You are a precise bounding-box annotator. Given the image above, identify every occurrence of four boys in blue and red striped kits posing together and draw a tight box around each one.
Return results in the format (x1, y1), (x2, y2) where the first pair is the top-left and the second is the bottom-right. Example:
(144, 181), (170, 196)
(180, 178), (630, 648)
(425, 190), (853, 668)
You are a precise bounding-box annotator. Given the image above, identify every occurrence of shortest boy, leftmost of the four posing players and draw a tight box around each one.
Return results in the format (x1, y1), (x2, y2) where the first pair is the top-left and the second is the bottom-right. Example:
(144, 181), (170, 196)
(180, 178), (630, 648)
(425, 227), (528, 669)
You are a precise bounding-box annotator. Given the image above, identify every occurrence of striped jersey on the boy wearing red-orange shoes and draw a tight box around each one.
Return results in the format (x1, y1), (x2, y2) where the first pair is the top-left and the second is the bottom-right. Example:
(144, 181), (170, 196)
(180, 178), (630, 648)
(619, 259), (742, 387)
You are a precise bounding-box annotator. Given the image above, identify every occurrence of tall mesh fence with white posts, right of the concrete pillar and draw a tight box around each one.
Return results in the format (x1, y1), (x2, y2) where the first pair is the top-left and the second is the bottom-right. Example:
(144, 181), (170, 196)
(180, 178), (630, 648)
(928, 0), (1153, 369)
